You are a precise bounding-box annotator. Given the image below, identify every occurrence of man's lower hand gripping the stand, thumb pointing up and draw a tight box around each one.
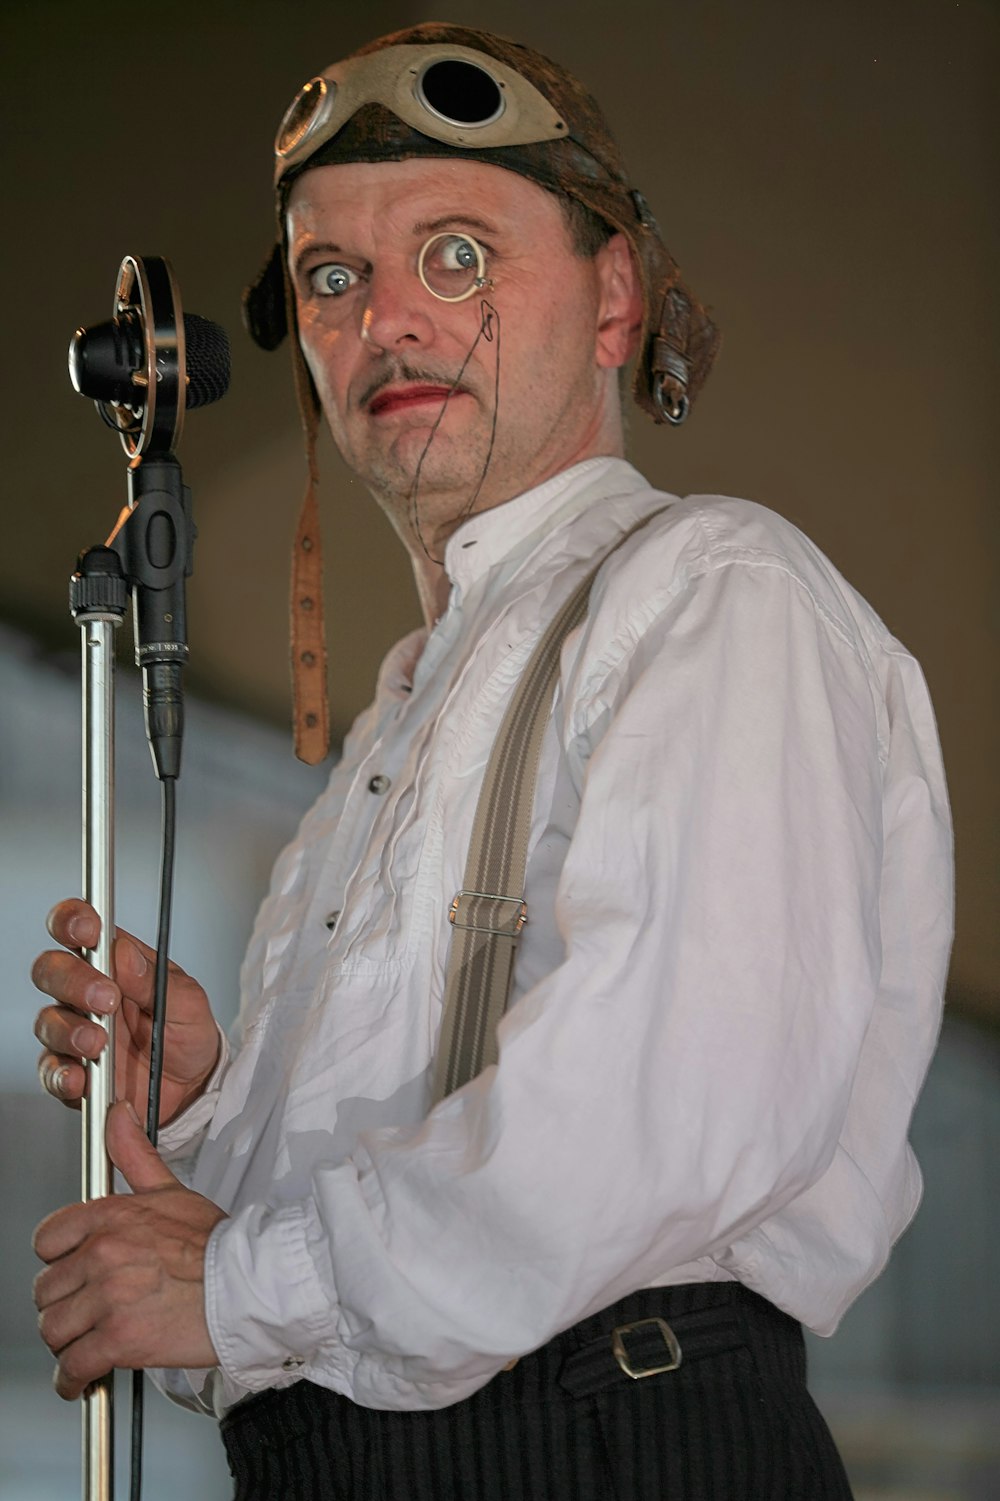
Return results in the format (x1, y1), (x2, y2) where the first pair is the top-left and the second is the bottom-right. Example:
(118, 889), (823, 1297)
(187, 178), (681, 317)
(35, 1103), (225, 1400)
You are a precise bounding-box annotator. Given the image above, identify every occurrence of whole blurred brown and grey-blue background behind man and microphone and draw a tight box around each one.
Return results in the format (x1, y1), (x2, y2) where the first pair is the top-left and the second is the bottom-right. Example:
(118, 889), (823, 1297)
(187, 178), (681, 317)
(0, 0), (1000, 1501)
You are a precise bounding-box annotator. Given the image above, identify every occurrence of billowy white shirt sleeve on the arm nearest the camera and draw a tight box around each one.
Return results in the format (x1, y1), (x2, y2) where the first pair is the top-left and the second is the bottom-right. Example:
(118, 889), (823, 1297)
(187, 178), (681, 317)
(209, 543), (942, 1408)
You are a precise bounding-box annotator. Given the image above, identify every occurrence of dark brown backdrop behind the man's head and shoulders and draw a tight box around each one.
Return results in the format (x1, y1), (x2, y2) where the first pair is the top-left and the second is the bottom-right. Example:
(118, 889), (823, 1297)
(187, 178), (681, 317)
(0, 0), (1000, 1024)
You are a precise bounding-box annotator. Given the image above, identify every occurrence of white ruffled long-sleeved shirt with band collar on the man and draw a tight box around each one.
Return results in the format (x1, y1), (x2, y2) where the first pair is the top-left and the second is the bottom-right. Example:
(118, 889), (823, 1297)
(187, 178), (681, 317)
(161, 459), (952, 1412)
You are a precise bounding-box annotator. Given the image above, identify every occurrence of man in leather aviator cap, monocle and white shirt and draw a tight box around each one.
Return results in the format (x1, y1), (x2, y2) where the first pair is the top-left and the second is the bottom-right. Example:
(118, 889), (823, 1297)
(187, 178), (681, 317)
(35, 26), (950, 1501)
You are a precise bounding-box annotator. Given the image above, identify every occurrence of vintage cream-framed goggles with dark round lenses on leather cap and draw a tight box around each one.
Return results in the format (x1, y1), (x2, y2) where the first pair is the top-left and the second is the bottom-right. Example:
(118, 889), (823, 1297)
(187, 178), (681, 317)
(275, 44), (569, 185)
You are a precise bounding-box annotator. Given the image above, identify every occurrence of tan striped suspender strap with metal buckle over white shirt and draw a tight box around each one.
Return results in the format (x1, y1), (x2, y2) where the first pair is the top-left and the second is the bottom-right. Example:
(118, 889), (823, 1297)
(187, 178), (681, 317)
(432, 512), (659, 1105)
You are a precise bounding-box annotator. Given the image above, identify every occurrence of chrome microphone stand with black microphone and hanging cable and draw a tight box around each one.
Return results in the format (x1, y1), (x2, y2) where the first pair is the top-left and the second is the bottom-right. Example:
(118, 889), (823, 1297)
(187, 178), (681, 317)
(69, 255), (230, 1501)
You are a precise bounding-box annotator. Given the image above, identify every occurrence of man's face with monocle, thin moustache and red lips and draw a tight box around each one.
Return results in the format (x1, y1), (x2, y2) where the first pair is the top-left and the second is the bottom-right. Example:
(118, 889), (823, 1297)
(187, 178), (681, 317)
(287, 159), (637, 545)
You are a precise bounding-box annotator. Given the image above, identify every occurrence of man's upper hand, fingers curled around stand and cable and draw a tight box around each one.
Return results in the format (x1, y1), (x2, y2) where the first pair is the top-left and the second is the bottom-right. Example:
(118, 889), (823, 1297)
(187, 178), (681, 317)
(32, 901), (219, 1126)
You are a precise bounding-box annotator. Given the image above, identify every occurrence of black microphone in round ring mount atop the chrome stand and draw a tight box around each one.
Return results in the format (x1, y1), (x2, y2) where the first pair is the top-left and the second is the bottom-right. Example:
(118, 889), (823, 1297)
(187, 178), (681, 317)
(69, 255), (230, 781)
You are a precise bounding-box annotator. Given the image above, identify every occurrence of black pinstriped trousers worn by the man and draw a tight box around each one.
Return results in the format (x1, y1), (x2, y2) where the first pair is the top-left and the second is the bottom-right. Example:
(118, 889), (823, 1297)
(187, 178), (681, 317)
(222, 1282), (851, 1501)
